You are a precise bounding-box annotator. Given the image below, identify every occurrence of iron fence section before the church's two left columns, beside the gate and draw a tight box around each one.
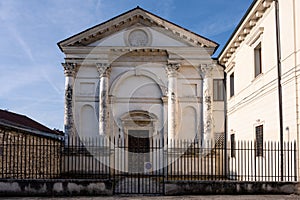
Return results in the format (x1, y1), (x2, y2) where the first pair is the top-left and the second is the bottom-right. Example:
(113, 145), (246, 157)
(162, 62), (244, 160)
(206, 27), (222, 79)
(61, 137), (112, 179)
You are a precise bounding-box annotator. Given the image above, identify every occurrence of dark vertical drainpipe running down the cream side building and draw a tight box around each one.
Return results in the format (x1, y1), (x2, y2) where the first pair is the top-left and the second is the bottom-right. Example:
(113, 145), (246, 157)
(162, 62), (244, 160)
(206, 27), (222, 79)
(274, 0), (284, 181)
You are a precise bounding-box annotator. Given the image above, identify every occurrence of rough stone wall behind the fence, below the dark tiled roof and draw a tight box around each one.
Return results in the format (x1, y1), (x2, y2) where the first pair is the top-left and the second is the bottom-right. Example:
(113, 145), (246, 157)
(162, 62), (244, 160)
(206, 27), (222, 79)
(0, 127), (62, 179)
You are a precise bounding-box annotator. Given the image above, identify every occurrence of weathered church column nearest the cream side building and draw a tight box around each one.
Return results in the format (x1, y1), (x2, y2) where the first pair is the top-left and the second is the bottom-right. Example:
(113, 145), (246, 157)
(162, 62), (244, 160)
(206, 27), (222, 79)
(200, 64), (215, 148)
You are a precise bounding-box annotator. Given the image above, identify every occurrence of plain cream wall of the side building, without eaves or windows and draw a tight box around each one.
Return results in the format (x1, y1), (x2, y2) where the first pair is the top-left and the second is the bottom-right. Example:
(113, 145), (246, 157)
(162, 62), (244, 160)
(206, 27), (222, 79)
(226, 0), (299, 141)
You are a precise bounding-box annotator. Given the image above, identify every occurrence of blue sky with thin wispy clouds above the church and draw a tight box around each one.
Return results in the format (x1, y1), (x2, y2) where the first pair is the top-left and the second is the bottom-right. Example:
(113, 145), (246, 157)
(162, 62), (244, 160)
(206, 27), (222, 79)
(0, 0), (252, 130)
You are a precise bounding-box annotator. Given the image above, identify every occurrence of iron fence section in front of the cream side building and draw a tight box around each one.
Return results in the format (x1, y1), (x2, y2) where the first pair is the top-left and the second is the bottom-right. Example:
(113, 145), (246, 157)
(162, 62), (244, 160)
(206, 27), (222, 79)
(228, 141), (297, 181)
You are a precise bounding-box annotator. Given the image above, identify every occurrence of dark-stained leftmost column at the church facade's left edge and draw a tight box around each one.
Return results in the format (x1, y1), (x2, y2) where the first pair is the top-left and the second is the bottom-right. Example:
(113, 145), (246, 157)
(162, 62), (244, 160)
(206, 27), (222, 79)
(62, 63), (76, 144)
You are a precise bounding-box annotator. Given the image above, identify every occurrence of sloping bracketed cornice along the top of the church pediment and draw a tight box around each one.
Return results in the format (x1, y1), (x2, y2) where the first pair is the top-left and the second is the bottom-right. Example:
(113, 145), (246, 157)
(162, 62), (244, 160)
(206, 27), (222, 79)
(58, 7), (218, 51)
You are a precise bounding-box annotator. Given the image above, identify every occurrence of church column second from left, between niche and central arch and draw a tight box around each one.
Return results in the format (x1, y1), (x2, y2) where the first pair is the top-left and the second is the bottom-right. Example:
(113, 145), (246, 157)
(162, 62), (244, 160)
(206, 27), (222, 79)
(96, 63), (111, 136)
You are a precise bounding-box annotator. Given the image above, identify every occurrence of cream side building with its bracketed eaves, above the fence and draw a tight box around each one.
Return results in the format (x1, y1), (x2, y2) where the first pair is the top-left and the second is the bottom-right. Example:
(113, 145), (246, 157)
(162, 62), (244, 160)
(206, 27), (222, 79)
(219, 0), (300, 178)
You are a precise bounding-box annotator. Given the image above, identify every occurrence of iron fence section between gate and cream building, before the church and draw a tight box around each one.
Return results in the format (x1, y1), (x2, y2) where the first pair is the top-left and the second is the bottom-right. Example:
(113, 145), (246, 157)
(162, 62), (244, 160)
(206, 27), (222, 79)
(167, 140), (228, 180)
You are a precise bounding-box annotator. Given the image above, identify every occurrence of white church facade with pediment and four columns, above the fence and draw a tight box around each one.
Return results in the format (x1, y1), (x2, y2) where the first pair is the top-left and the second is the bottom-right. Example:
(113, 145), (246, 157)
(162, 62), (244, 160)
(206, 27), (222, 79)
(58, 7), (225, 148)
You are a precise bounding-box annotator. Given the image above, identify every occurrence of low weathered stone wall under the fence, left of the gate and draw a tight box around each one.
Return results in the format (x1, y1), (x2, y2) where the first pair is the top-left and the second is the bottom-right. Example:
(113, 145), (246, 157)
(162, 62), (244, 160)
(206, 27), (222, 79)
(0, 180), (113, 196)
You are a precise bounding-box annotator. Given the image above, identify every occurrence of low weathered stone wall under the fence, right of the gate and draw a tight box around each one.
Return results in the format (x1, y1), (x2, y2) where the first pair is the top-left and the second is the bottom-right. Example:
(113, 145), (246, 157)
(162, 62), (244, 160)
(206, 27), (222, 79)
(165, 181), (298, 196)
